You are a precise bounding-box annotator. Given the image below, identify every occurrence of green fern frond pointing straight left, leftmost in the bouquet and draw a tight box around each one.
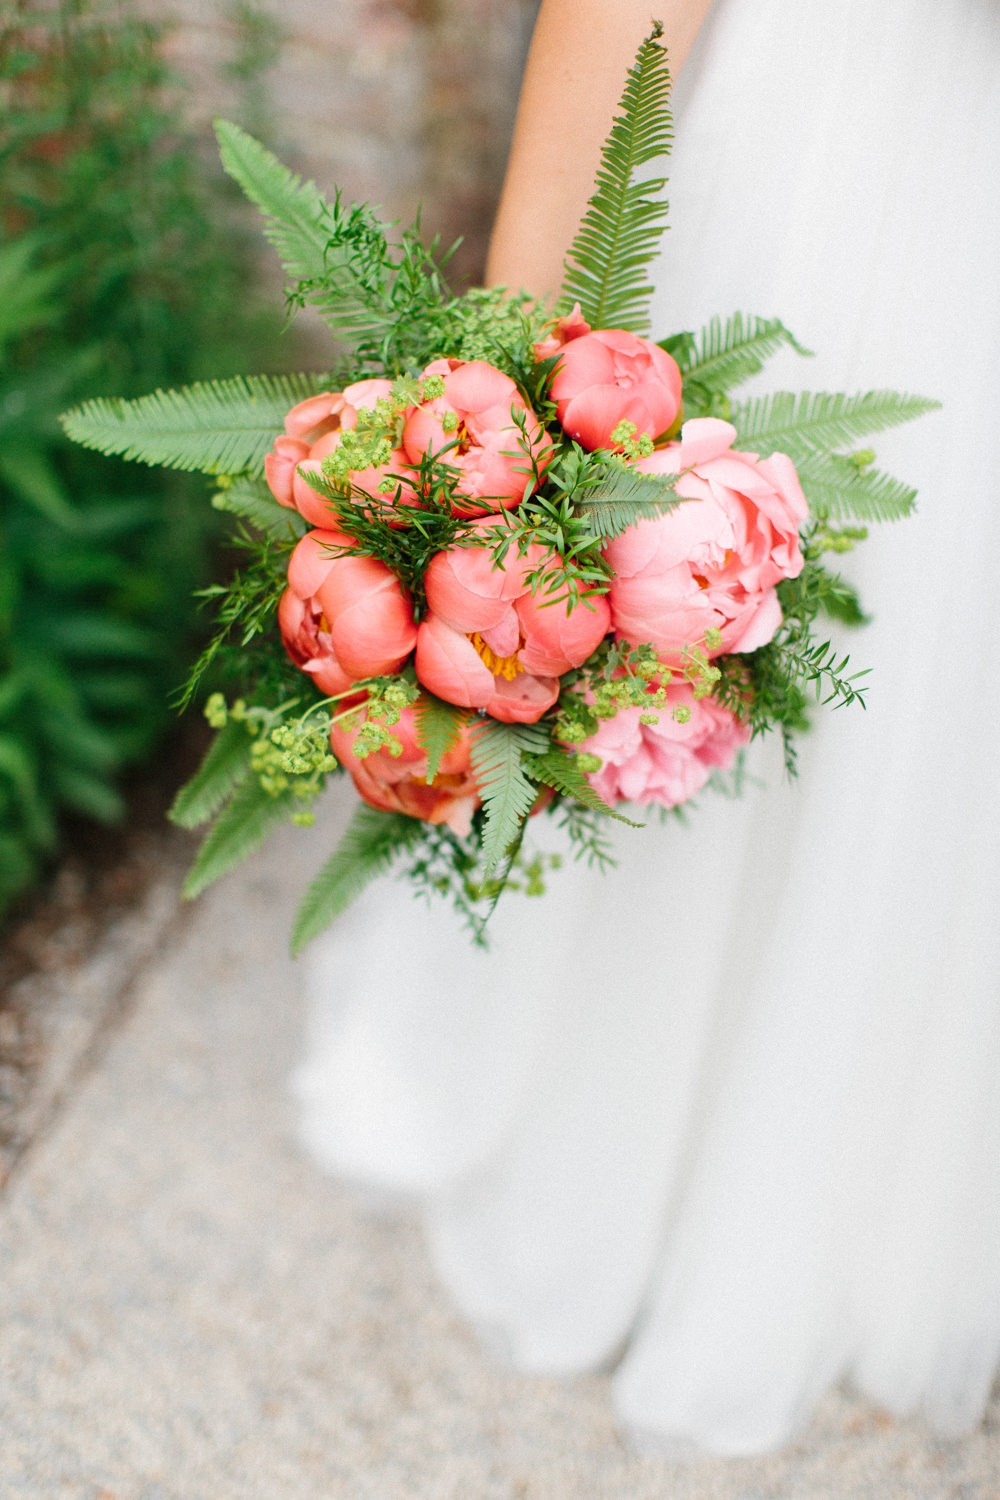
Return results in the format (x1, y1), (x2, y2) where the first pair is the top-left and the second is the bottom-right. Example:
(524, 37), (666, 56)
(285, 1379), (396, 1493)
(61, 375), (322, 474)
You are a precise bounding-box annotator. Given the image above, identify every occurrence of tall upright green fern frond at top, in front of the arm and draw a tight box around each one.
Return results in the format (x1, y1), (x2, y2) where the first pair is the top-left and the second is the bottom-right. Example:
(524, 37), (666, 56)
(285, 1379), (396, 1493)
(559, 23), (673, 333)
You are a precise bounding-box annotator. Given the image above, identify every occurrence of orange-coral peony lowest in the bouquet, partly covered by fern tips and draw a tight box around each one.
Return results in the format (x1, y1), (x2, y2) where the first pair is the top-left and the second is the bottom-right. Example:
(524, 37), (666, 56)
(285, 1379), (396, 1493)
(330, 708), (480, 834)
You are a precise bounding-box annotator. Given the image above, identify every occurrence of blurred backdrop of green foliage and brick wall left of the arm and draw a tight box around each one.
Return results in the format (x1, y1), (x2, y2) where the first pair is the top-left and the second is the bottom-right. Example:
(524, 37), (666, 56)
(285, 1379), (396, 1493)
(0, 0), (535, 920)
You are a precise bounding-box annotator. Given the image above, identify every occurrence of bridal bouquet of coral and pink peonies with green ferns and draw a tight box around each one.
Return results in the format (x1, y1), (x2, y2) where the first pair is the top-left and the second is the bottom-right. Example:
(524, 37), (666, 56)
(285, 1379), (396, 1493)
(66, 27), (933, 948)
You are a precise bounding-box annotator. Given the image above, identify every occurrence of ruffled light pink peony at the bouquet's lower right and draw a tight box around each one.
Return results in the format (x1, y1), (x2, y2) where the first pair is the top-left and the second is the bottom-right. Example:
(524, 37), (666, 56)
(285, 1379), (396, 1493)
(579, 683), (750, 807)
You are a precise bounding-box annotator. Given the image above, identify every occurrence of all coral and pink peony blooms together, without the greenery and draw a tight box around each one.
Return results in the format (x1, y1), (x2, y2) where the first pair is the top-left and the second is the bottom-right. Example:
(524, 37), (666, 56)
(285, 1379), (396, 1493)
(265, 327), (805, 833)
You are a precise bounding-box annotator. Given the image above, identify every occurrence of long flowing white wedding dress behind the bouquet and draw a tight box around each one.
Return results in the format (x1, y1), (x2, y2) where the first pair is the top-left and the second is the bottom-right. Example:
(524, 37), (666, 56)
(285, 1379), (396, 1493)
(297, 0), (1000, 1452)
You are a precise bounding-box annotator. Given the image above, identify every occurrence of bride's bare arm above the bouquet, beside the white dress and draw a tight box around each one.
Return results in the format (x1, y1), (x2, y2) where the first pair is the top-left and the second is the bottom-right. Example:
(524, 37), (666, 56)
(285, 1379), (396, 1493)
(486, 0), (711, 297)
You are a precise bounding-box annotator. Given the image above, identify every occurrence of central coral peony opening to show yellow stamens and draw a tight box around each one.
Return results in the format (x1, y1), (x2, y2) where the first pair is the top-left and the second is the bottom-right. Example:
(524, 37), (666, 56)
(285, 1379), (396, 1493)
(414, 522), (610, 723)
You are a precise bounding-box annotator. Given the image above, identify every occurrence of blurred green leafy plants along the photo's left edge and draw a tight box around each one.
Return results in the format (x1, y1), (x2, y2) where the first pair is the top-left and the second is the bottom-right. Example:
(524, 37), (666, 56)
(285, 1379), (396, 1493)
(0, 0), (289, 915)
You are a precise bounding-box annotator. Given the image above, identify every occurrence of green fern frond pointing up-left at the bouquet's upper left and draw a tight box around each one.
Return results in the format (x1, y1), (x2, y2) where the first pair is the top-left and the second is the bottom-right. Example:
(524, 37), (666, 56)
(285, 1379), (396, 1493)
(216, 120), (390, 345)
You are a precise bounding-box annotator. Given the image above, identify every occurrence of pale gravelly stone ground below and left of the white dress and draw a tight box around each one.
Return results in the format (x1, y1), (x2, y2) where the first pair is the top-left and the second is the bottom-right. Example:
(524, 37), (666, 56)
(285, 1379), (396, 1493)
(0, 833), (1000, 1500)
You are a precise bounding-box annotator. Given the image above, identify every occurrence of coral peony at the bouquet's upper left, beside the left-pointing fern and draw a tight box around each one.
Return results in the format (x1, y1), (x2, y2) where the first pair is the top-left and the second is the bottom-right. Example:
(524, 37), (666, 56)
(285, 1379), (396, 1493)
(264, 380), (415, 528)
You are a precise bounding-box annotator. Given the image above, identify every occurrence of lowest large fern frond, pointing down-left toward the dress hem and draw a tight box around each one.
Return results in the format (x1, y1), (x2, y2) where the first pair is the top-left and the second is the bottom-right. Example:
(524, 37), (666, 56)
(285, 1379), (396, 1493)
(292, 804), (424, 956)
